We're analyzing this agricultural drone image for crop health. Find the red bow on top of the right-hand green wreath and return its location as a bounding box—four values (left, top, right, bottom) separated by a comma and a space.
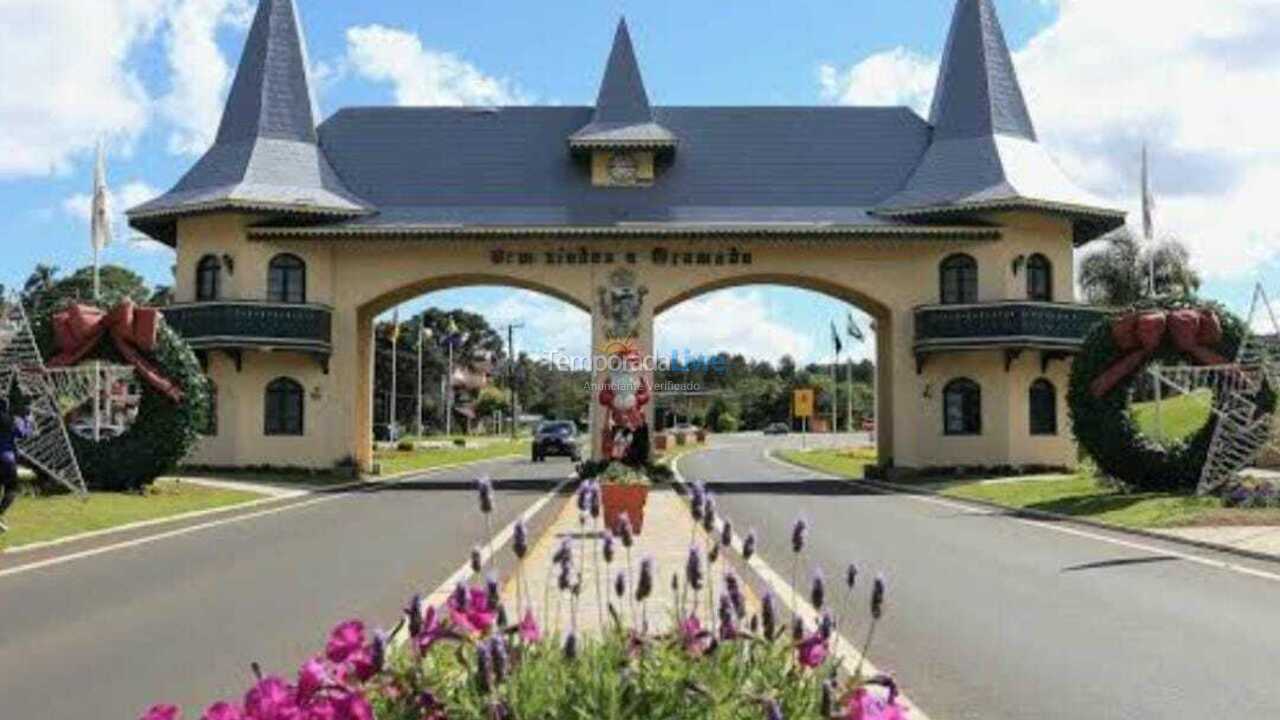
1089, 310, 1228, 397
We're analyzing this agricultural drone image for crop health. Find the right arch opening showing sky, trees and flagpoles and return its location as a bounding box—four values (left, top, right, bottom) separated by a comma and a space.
654, 274, 892, 461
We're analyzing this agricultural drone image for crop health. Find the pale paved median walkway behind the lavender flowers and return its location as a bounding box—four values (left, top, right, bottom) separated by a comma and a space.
503, 487, 759, 634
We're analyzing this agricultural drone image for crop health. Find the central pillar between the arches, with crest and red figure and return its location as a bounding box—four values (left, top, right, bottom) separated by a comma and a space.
590, 268, 657, 464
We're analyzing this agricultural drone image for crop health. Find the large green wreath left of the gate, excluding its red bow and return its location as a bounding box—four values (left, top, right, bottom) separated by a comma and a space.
32, 299, 211, 492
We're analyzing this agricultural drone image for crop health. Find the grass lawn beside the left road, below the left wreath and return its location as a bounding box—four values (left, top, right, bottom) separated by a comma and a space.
0, 480, 262, 547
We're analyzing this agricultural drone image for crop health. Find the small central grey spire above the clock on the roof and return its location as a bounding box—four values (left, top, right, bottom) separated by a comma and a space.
570, 18, 676, 147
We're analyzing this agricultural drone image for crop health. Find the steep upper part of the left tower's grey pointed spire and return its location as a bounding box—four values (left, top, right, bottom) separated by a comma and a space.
218, 0, 316, 142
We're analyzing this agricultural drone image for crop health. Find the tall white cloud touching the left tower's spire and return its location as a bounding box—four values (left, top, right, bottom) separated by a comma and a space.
160, 0, 253, 156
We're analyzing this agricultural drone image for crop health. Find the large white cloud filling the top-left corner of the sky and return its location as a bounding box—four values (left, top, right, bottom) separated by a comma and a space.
0, 0, 165, 178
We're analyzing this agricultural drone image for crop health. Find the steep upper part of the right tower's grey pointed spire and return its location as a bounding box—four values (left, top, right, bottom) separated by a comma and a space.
929, 0, 1036, 141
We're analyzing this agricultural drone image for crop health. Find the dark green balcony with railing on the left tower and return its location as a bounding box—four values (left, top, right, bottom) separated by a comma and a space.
163, 300, 333, 357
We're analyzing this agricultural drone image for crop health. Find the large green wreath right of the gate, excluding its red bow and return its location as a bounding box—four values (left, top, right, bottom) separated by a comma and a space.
1068, 299, 1276, 492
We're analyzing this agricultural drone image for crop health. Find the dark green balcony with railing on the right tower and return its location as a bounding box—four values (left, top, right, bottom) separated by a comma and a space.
915, 301, 1107, 366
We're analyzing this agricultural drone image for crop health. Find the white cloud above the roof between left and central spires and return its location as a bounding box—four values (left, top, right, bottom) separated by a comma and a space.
346, 24, 526, 105
